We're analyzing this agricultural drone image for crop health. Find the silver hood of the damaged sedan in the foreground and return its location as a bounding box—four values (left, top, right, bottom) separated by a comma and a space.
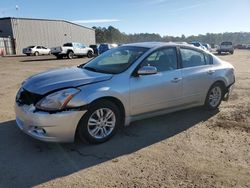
23, 67, 112, 95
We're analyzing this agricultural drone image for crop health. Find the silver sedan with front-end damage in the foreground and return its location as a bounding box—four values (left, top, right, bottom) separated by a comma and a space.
15, 42, 235, 143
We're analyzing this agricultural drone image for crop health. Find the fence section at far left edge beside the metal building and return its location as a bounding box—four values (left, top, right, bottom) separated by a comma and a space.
0, 38, 15, 56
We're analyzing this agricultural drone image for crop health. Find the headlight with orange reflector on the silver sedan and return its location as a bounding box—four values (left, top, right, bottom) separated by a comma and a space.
36, 88, 80, 111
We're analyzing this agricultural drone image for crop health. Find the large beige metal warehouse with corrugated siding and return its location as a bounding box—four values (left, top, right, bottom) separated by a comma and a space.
0, 17, 95, 54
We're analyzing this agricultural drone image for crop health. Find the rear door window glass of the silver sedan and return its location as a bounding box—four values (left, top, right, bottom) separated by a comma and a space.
180, 48, 206, 68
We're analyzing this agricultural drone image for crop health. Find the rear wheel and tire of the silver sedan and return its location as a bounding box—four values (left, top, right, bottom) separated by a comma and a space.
204, 82, 225, 110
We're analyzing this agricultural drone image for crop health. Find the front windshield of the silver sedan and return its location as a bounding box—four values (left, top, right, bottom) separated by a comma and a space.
82, 46, 148, 74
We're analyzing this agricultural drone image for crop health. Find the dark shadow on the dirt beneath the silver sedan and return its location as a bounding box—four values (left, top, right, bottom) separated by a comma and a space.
0, 108, 218, 187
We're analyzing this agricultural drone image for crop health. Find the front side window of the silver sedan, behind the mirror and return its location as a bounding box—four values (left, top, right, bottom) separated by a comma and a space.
141, 48, 177, 72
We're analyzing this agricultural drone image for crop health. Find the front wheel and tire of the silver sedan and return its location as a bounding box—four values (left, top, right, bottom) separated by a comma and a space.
77, 100, 122, 144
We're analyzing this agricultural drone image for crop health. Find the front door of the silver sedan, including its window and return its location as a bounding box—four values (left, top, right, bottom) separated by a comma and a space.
130, 47, 182, 115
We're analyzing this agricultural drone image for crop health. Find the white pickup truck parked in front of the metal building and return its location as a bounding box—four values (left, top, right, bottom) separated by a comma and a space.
51, 42, 94, 59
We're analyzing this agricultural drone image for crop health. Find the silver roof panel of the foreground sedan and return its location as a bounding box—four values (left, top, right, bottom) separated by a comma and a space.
122, 42, 193, 48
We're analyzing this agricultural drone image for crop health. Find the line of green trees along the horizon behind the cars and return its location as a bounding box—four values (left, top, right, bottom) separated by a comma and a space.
93, 26, 250, 45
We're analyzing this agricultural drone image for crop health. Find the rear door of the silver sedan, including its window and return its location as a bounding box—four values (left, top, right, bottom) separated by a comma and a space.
180, 47, 215, 104
